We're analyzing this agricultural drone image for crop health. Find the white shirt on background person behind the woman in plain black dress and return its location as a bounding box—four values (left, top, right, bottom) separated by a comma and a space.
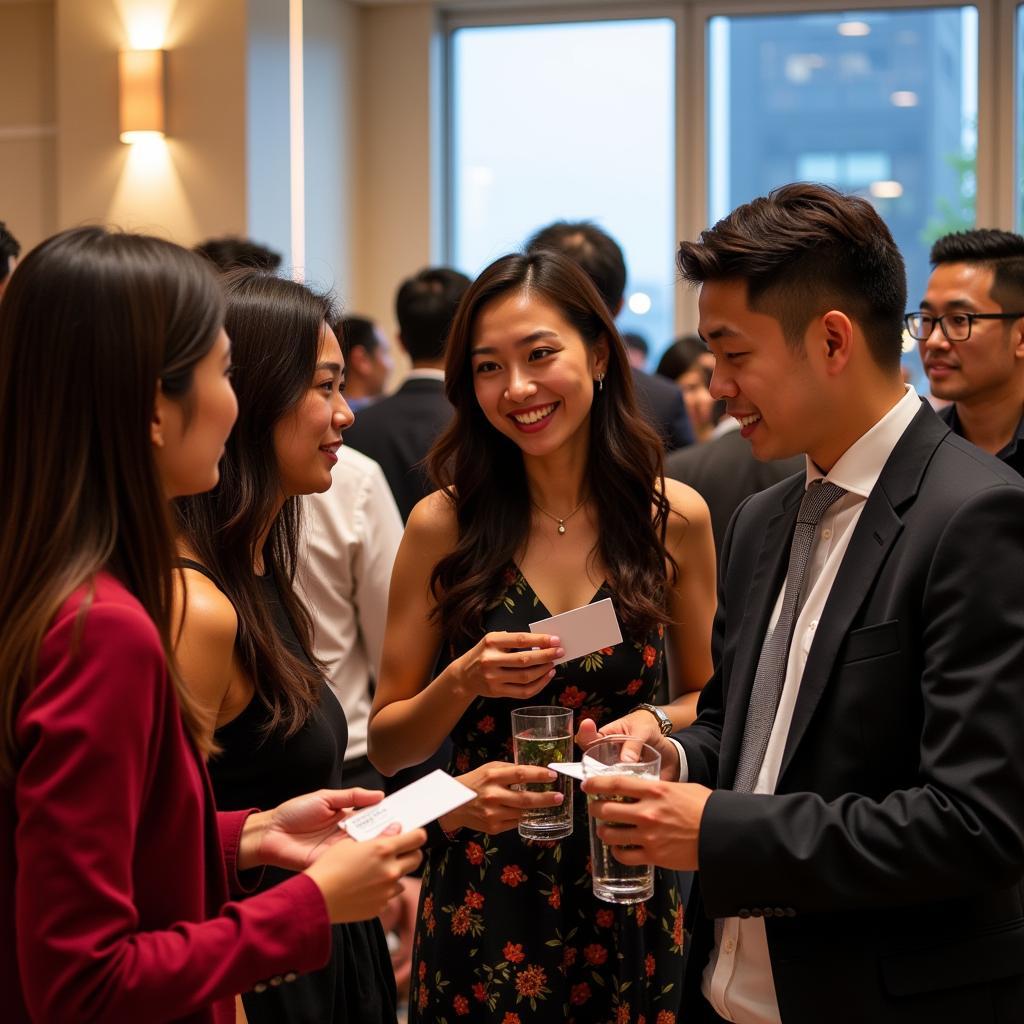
296, 445, 402, 761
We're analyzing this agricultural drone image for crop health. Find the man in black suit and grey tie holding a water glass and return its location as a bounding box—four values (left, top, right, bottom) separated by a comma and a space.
580, 184, 1024, 1024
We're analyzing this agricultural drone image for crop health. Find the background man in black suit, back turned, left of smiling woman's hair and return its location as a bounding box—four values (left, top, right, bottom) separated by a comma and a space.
345, 267, 469, 522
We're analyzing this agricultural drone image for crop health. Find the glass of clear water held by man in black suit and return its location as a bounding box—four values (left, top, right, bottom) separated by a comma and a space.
583, 736, 662, 903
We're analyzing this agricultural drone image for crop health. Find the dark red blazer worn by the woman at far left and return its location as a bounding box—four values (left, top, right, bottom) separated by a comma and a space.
13, 604, 330, 1024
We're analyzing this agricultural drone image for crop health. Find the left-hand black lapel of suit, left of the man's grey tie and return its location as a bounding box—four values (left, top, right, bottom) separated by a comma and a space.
719, 478, 804, 786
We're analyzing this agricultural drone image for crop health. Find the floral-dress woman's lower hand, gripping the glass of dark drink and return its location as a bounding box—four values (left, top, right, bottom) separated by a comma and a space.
438, 761, 563, 836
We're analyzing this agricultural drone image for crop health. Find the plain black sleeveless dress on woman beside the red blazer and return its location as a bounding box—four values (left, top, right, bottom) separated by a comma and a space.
182, 560, 396, 1024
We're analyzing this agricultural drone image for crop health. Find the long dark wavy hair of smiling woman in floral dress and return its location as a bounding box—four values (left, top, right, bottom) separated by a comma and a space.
428, 251, 676, 644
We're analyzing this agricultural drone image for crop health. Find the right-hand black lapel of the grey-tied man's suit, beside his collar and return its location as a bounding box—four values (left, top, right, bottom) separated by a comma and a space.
778, 402, 949, 781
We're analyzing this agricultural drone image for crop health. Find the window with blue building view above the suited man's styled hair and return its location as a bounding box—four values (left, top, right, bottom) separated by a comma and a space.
708, 7, 978, 380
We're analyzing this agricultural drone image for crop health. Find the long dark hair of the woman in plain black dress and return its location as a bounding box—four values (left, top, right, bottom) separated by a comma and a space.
174, 269, 333, 735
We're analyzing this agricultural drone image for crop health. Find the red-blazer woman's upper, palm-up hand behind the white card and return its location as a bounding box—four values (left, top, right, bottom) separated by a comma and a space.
239, 788, 384, 871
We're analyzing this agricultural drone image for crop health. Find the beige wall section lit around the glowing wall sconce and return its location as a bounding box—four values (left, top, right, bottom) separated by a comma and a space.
56, 0, 246, 245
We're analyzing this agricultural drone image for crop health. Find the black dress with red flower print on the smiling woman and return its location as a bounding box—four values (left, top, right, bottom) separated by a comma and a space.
409, 567, 683, 1024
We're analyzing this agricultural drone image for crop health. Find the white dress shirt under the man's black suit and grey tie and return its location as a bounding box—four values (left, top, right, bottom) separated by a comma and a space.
680, 386, 921, 1024
